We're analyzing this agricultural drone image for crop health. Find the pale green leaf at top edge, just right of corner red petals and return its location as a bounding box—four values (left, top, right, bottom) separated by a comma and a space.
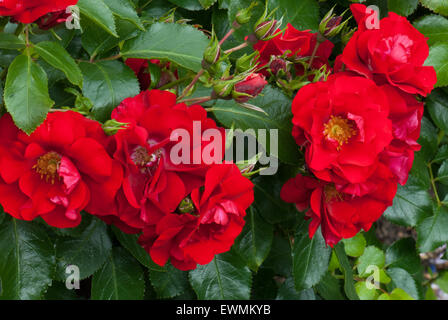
77, 0, 118, 38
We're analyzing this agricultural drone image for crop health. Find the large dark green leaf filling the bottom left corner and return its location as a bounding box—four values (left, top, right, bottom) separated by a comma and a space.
0, 218, 55, 300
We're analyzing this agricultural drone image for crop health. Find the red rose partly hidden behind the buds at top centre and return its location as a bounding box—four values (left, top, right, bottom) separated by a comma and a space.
254, 24, 334, 76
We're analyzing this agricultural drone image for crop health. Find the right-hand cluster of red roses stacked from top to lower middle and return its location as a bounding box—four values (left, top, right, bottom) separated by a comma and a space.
281, 4, 436, 246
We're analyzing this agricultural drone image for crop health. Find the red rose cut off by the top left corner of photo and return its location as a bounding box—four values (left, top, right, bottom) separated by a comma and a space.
0, 0, 78, 23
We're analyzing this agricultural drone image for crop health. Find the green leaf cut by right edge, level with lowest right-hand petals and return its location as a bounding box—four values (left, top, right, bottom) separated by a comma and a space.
417, 207, 448, 252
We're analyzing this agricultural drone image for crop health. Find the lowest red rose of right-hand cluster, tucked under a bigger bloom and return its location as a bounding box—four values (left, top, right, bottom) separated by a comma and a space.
280, 165, 397, 247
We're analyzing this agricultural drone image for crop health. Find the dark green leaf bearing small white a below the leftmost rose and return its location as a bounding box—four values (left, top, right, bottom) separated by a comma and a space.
56, 218, 112, 280
